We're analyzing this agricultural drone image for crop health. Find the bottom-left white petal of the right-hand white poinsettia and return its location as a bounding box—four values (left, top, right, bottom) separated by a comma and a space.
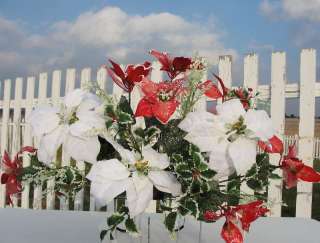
209, 139, 235, 179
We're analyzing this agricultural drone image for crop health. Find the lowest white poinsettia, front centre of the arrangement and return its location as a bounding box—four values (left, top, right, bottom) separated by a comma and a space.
87, 137, 181, 217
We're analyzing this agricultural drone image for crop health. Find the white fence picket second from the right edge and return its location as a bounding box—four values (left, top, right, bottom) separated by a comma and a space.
268, 52, 286, 217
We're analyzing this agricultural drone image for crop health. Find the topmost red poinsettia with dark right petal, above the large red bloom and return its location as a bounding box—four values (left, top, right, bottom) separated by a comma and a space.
150, 50, 192, 79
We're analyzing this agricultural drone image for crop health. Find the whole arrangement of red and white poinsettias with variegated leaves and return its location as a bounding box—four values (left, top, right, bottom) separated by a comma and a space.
1, 50, 320, 243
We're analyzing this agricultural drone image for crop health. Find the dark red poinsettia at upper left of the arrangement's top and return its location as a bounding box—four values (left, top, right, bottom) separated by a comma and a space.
106, 60, 151, 93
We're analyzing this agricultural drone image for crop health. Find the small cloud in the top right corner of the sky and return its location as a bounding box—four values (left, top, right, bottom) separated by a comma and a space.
260, 0, 320, 21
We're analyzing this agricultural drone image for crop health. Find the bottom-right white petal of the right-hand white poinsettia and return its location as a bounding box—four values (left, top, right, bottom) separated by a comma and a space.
228, 137, 257, 175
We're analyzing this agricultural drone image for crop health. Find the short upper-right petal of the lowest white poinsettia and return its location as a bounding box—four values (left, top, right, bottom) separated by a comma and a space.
142, 147, 169, 170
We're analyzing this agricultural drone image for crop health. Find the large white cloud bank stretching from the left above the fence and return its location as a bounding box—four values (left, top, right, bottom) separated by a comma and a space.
0, 7, 237, 77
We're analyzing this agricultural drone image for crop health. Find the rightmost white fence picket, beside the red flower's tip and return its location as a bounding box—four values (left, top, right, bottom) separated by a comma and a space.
296, 49, 316, 218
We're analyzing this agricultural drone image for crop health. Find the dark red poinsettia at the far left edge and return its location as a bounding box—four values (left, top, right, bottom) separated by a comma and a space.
1, 146, 36, 204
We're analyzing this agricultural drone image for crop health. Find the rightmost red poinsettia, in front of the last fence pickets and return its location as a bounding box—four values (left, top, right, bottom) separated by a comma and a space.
281, 145, 320, 189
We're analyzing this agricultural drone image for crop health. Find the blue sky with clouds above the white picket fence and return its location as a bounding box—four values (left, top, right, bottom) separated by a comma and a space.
0, 0, 320, 113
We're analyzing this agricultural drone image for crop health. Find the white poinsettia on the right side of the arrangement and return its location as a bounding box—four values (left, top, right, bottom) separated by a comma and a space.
179, 99, 275, 178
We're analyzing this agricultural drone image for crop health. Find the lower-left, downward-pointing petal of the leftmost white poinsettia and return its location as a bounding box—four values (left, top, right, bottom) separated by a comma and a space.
37, 126, 67, 164
